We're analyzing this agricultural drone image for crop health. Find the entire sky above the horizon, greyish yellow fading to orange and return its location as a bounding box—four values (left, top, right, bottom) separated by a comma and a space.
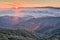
0, 0, 60, 8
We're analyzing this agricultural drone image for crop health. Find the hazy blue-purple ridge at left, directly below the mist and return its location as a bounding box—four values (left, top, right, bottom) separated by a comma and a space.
0, 16, 34, 27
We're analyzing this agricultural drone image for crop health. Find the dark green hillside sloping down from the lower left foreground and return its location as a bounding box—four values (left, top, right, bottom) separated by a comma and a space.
0, 28, 40, 40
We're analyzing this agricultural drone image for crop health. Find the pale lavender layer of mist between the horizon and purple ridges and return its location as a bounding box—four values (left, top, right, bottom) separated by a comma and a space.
0, 8, 60, 17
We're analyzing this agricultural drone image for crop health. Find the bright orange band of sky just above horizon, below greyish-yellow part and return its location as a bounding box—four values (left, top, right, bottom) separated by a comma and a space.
0, 3, 60, 8
